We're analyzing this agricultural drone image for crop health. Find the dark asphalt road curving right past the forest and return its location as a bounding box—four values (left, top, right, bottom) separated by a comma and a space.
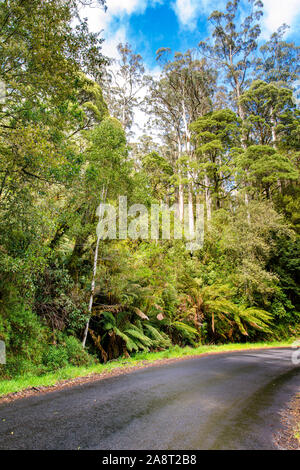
0, 349, 300, 450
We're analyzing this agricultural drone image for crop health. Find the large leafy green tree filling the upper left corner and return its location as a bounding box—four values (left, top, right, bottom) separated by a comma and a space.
0, 0, 105, 209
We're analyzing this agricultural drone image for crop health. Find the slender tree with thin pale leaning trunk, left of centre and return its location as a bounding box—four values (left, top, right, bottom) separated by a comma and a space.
67, 117, 132, 346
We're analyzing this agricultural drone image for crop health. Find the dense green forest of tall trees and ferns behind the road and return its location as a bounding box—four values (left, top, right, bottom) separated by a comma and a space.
0, 0, 300, 378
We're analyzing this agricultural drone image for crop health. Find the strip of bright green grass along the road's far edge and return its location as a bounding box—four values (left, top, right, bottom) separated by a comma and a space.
0, 339, 294, 397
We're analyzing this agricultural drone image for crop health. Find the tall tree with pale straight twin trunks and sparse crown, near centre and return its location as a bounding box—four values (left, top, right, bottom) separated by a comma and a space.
150, 48, 216, 232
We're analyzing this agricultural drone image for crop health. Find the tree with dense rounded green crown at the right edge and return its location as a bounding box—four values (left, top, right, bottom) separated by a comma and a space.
238, 80, 299, 199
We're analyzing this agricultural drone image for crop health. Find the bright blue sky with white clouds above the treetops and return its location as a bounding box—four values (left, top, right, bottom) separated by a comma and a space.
82, 0, 300, 71
